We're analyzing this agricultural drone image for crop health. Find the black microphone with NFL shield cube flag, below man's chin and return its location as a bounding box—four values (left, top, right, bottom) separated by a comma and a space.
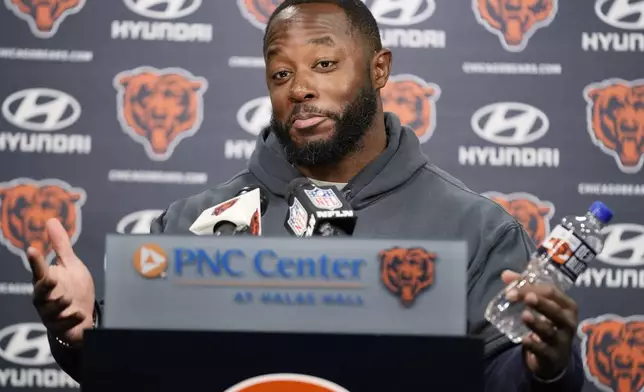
284, 177, 358, 237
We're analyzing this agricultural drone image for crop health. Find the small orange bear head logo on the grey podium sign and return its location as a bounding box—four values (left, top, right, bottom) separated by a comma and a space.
378, 247, 437, 307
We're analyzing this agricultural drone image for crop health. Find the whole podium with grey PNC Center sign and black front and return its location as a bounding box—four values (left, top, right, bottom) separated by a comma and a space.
82, 235, 484, 392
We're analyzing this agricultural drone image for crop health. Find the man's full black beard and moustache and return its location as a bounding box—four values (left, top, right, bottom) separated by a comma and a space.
270, 84, 378, 167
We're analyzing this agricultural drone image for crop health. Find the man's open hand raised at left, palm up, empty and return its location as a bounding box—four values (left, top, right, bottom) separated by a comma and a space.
27, 219, 95, 345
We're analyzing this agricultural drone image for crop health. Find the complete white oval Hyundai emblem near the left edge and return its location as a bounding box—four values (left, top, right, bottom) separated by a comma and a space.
1, 88, 81, 132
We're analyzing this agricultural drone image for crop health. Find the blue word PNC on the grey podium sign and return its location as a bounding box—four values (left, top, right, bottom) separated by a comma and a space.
174, 248, 245, 277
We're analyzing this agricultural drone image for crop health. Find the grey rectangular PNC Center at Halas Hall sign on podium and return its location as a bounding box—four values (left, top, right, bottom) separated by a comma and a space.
103, 235, 467, 336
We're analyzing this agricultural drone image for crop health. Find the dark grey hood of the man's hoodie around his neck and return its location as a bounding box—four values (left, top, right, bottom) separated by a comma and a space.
248, 113, 428, 208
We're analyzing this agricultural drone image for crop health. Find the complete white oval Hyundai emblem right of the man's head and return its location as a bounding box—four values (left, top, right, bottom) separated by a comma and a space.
471, 102, 550, 146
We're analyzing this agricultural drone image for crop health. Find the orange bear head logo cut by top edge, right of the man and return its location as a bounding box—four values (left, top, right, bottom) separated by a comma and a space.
472, 0, 558, 52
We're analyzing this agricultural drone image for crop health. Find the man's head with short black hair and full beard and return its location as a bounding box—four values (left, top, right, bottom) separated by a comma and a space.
264, 0, 391, 166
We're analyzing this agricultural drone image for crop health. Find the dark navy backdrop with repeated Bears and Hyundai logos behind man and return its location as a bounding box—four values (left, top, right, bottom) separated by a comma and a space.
0, 0, 644, 392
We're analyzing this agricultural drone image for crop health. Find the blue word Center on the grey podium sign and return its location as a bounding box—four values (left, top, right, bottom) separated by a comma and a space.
253, 249, 367, 280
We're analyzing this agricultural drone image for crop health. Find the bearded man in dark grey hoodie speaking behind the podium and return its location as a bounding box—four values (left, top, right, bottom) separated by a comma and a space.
28, 0, 583, 392
